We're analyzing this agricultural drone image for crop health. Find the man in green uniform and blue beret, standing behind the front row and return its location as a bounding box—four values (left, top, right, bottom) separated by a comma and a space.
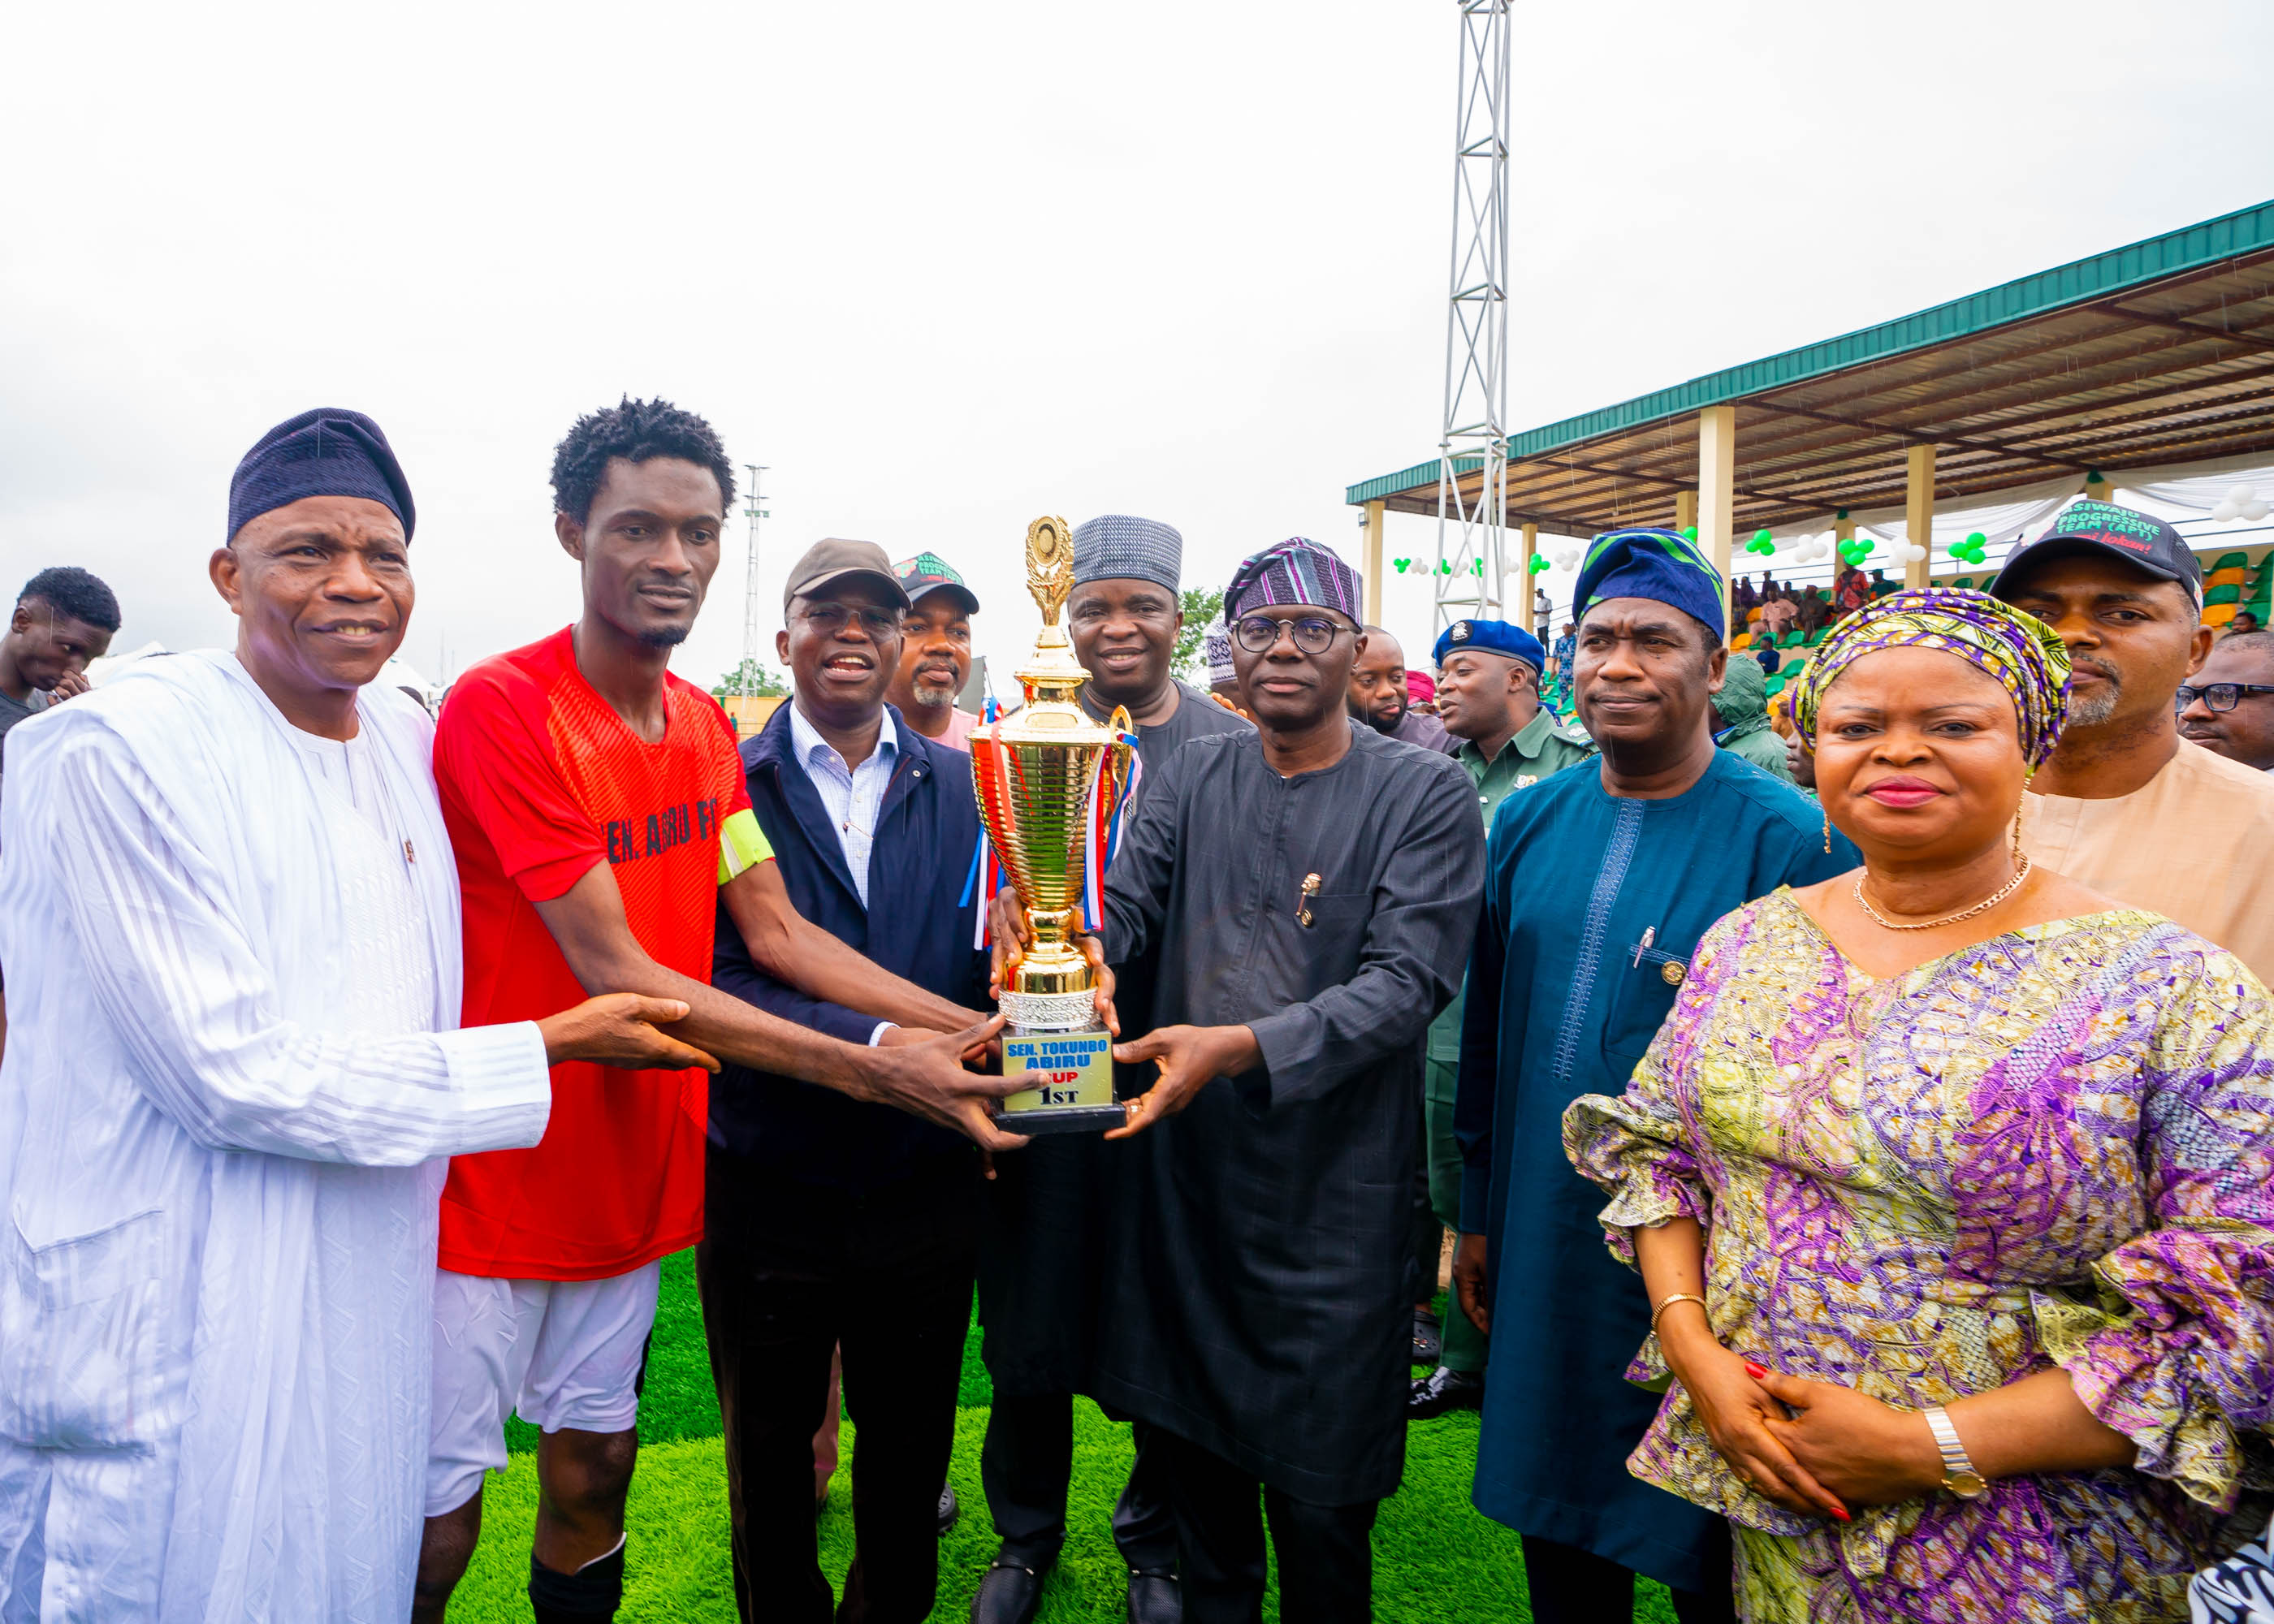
1405, 621, 1594, 1422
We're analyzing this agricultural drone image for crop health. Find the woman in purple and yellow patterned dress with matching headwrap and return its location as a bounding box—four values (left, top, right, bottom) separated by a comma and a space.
1564, 591, 2274, 1624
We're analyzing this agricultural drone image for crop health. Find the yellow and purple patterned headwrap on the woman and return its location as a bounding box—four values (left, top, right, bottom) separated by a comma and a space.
1792, 587, 2069, 771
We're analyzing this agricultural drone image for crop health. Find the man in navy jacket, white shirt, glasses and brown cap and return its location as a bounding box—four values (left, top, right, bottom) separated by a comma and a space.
698, 542, 987, 1624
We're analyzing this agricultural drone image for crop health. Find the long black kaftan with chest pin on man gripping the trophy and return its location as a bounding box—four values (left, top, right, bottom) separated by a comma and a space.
1092, 726, 1485, 1505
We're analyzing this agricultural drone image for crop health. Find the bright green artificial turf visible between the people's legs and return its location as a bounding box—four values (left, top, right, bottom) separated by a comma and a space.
450, 1253, 1674, 1624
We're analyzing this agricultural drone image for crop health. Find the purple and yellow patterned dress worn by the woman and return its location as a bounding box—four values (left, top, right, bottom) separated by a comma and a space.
1564, 889, 2274, 1624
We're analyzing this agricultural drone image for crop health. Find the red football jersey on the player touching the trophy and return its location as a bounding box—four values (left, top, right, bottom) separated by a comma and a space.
434, 630, 771, 1281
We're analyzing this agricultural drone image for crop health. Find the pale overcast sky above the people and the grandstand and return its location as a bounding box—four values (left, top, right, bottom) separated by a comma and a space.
0, 0, 2274, 685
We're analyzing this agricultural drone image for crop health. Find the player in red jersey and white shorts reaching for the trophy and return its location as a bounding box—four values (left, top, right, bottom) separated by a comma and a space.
421, 412, 1023, 1624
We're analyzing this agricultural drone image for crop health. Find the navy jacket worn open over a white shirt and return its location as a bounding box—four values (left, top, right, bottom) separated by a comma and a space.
710, 703, 989, 1196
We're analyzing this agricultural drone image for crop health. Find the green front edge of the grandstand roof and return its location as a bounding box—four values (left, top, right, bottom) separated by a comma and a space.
1342, 200, 2274, 508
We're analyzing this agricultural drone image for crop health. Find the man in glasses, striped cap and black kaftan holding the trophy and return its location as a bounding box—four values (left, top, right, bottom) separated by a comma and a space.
1023, 539, 1485, 1624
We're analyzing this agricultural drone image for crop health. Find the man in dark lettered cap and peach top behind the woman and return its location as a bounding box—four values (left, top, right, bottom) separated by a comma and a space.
1990, 500, 2274, 980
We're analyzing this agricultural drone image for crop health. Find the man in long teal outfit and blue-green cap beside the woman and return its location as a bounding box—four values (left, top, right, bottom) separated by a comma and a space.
1453, 530, 1858, 1624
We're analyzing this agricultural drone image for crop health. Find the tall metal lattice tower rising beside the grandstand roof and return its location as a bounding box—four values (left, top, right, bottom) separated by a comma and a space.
1433, 0, 1530, 630
